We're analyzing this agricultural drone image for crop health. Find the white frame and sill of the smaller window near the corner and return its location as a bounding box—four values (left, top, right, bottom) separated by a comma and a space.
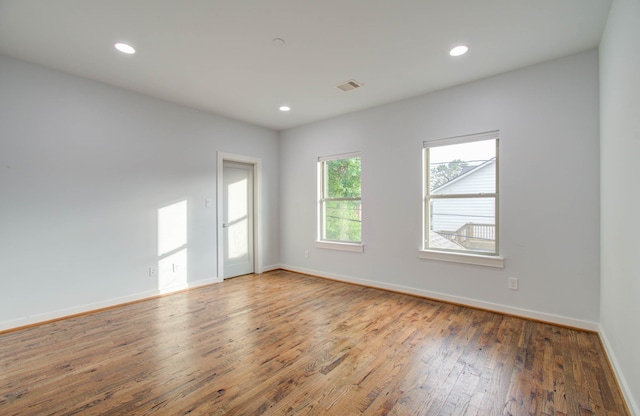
315, 152, 364, 252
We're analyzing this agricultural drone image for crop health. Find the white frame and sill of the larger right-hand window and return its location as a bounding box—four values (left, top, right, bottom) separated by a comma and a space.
419, 130, 504, 267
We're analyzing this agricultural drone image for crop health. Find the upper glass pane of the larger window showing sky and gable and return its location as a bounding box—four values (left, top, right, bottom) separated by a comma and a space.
428, 139, 496, 195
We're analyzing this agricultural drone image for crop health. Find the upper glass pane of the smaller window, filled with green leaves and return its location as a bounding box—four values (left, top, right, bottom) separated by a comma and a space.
325, 157, 360, 198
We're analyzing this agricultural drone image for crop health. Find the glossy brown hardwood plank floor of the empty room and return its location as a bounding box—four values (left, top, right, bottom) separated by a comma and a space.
0, 271, 628, 416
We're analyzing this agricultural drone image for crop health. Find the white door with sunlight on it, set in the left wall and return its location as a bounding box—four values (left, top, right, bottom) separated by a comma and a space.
222, 161, 254, 279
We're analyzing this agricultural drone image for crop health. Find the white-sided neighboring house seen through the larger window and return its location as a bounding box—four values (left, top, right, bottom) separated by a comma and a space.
431, 158, 496, 249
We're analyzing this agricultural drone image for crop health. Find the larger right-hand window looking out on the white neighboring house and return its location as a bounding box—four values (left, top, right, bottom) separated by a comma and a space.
423, 131, 502, 267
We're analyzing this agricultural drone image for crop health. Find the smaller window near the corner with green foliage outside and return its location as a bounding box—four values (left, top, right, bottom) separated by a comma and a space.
318, 153, 362, 251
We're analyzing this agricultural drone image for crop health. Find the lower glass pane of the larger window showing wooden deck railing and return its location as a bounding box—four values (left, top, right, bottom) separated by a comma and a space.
428, 198, 496, 253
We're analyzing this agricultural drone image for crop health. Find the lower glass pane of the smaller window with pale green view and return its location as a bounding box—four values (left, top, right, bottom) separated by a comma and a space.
324, 201, 362, 242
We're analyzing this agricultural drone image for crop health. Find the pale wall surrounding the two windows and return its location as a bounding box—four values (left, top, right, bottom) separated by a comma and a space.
280, 50, 600, 328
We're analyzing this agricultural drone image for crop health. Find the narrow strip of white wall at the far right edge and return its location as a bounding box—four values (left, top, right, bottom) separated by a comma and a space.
600, 0, 640, 415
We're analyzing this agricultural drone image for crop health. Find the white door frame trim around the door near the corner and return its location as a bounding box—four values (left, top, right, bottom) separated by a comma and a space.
216, 152, 262, 280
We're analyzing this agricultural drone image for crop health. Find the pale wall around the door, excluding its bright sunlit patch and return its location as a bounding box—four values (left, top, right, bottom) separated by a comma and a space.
0, 57, 279, 329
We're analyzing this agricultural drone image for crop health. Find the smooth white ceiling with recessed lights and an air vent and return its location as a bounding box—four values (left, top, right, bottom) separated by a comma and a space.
0, 0, 611, 130
